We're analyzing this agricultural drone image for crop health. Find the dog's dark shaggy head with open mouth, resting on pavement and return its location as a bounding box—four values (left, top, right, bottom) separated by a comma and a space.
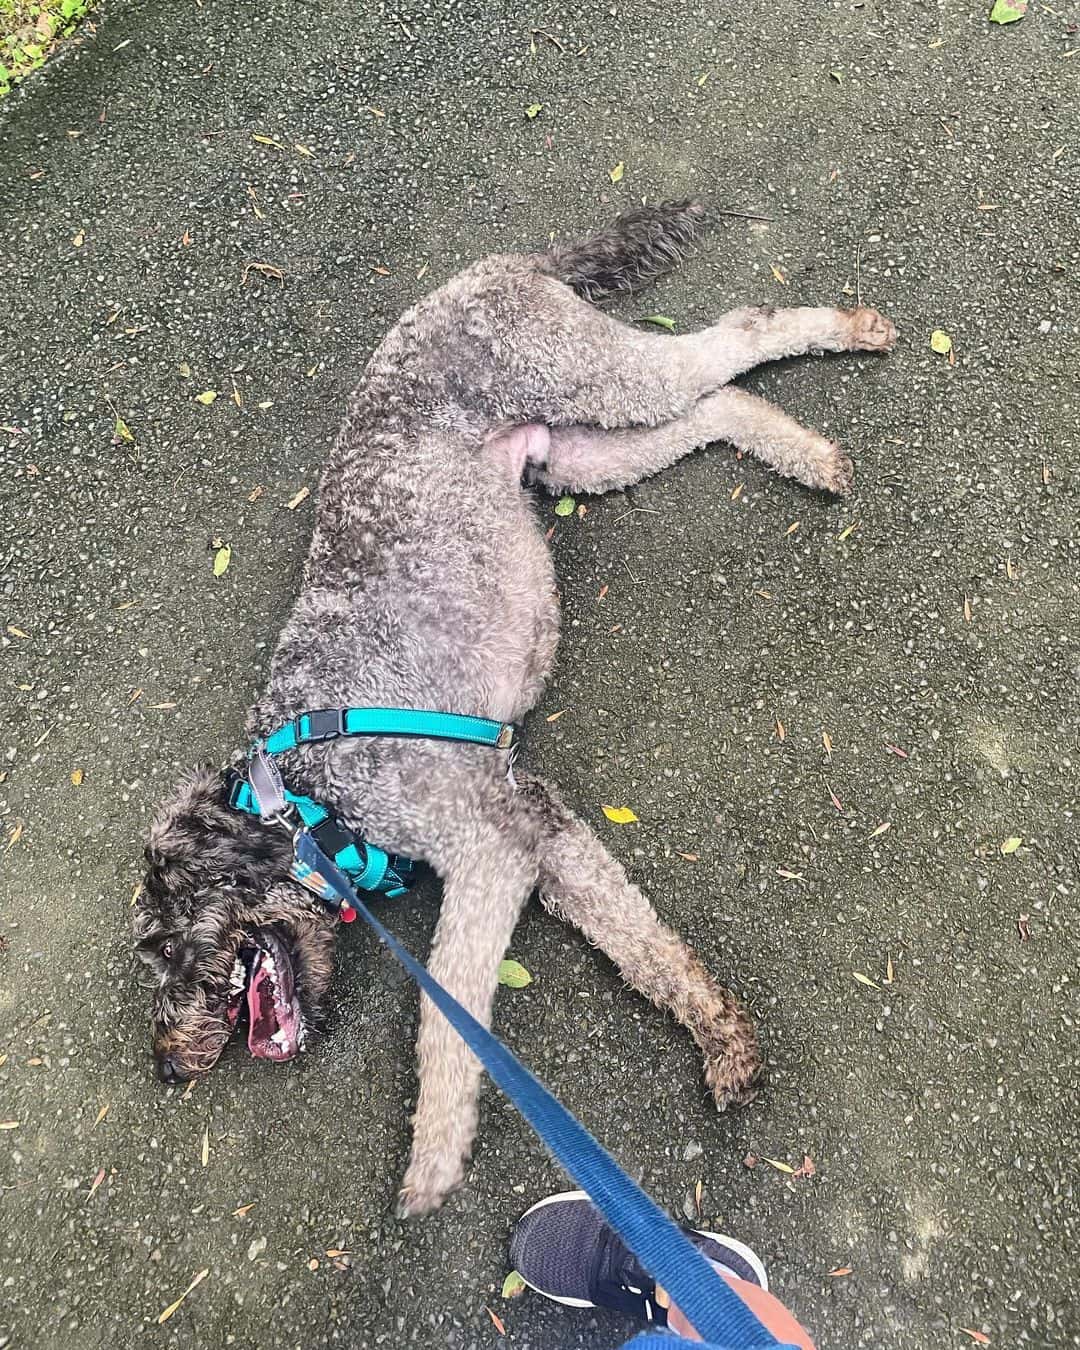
135, 768, 336, 1083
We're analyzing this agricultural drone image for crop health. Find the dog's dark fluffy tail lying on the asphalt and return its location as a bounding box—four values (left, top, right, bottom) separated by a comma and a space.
541, 198, 706, 300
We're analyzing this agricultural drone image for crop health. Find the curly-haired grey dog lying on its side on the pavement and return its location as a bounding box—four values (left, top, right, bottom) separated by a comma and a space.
135, 203, 895, 1214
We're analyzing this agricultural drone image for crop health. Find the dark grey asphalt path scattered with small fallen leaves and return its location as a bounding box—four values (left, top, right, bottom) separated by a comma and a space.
0, 0, 1080, 1350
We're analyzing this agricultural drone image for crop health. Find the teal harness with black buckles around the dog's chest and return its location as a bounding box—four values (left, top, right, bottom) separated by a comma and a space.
227, 707, 514, 923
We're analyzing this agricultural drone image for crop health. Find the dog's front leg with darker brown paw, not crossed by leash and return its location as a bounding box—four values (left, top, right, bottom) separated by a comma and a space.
520, 775, 760, 1110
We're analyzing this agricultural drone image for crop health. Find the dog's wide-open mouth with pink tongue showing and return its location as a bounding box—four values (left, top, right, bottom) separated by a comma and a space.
227, 927, 304, 1060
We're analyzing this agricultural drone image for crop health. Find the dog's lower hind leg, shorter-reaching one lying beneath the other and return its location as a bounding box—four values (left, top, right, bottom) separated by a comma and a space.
536, 387, 852, 493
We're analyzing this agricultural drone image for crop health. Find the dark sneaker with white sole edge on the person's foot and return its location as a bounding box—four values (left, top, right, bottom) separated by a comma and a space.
510, 1191, 768, 1326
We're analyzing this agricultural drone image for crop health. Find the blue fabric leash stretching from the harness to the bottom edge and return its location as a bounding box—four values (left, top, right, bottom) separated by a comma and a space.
296, 830, 779, 1350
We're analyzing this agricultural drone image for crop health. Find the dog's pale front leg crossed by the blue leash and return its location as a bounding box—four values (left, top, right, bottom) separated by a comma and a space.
398, 826, 536, 1218
